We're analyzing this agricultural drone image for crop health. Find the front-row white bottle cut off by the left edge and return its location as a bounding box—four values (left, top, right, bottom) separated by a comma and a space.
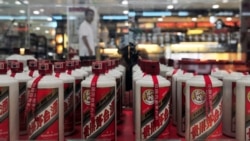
0, 61, 19, 141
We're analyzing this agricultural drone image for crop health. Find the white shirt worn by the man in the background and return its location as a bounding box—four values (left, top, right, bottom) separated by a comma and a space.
79, 21, 95, 56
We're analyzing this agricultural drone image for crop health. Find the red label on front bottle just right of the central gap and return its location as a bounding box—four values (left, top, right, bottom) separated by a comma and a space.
140, 87, 171, 140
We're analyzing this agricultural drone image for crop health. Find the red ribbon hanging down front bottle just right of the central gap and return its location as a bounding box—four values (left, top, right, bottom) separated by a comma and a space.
152, 75, 159, 125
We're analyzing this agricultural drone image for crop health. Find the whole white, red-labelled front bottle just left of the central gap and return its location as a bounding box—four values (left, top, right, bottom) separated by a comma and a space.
81, 61, 117, 141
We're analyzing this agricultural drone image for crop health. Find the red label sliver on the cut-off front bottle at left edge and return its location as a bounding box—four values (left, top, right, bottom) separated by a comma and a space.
0, 87, 10, 140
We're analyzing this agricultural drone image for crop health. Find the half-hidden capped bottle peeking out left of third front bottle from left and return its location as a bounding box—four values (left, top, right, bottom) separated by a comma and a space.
65, 60, 87, 124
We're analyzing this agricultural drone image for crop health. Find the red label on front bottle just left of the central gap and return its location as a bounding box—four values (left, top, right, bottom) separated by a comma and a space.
82, 87, 116, 141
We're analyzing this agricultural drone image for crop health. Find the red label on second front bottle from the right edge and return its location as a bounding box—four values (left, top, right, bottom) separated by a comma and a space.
189, 87, 222, 140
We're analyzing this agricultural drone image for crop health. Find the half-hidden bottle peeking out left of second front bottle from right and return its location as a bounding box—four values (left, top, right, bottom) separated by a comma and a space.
176, 75, 193, 137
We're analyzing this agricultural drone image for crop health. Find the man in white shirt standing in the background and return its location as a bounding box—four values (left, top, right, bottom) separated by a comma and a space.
79, 8, 95, 60
